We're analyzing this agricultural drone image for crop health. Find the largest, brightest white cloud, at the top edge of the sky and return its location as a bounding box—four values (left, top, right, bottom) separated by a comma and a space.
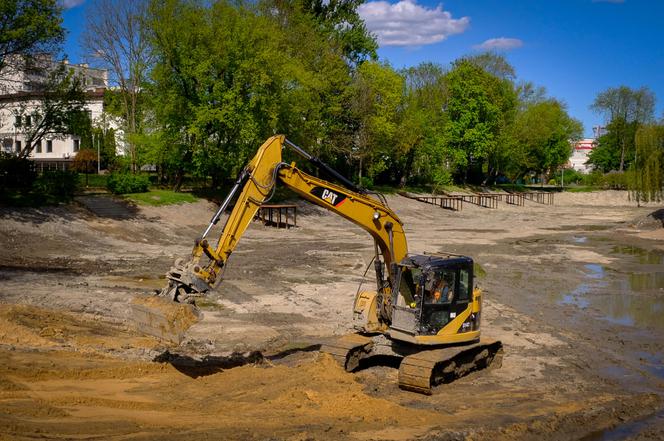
357, 0, 470, 46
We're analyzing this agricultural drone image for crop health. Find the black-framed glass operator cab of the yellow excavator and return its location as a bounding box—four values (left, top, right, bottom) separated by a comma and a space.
390, 254, 480, 345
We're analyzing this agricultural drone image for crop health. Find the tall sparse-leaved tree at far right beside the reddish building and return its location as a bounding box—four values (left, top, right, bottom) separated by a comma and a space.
589, 86, 655, 171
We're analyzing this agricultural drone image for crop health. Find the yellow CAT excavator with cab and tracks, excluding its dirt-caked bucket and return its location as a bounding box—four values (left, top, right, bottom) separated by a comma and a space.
143, 136, 502, 394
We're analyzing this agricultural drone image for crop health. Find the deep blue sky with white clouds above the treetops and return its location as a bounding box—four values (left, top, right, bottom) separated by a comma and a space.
64, 0, 664, 136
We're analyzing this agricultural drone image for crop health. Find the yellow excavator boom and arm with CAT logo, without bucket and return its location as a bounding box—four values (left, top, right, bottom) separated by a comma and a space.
165, 135, 408, 300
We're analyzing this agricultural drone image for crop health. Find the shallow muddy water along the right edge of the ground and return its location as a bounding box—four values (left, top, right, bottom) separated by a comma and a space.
557, 236, 664, 434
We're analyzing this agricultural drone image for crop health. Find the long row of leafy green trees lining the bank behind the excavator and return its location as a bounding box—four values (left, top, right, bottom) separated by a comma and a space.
118, 0, 592, 188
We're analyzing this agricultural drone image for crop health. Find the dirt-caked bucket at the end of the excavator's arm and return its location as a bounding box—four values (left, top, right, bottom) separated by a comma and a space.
130, 295, 200, 344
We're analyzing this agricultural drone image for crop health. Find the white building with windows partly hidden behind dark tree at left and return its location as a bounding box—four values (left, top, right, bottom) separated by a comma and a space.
0, 58, 115, 168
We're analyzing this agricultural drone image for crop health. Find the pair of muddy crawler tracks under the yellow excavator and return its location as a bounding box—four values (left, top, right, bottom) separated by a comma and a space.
321, 334, 503, 395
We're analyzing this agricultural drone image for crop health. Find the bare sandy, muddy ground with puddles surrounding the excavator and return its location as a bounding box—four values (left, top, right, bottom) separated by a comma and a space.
0, 192, 664, 441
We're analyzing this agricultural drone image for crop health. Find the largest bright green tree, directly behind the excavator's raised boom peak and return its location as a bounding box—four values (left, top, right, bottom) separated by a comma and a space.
146, 0, 364, 185
